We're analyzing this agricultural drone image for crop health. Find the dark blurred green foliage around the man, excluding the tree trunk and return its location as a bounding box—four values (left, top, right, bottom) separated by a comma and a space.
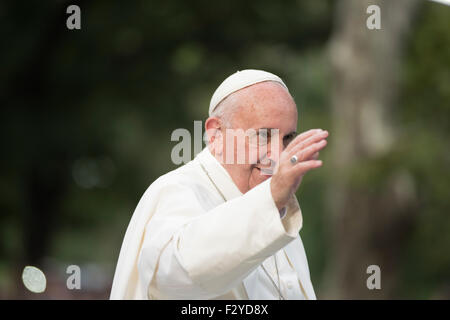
0, 1, 450, 298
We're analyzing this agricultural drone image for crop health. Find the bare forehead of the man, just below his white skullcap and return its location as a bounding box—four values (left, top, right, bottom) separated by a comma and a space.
234, 82, 298, 133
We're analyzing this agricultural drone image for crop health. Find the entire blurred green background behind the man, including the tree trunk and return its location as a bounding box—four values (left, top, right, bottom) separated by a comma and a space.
0, 0, 450, 299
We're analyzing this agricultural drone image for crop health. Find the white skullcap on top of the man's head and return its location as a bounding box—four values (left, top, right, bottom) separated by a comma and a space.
209, 69, 287, 116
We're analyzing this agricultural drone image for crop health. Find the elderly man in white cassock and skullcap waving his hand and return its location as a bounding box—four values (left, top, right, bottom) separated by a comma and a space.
111, 70, 328, 299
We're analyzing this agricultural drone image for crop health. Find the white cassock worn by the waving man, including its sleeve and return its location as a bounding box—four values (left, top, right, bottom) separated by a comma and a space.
111, 148, 316, 299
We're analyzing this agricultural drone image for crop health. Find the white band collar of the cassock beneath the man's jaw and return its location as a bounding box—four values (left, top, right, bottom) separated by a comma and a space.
195, 146, 242, 201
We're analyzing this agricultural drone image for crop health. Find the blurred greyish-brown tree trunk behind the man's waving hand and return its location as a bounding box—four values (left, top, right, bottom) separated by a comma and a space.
326, 0, 417, 299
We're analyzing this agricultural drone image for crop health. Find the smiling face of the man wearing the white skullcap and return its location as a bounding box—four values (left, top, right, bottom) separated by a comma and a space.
221, 82, 298, 193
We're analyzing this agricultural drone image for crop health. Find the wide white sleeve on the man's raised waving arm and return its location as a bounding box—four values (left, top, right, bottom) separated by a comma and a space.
138, 179, 302, 299
